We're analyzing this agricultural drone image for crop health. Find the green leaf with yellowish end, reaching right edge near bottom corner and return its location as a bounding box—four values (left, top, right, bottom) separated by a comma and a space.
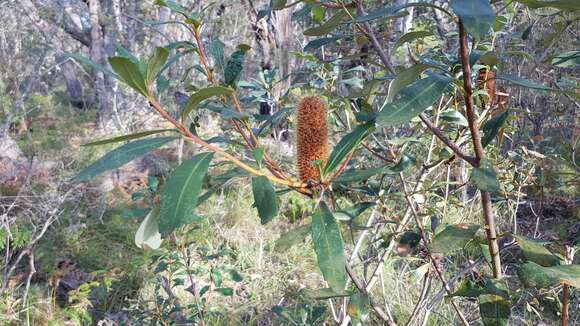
518, 262, 580, 288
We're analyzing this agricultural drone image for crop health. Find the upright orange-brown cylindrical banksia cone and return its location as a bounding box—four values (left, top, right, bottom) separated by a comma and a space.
297, 96, 328, 182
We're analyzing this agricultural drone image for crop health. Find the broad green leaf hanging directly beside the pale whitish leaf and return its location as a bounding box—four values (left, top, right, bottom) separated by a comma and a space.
159, 153, 213, 236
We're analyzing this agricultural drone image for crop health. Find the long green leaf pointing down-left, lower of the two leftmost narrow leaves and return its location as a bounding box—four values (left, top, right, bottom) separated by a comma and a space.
72, 137, 176, 183
